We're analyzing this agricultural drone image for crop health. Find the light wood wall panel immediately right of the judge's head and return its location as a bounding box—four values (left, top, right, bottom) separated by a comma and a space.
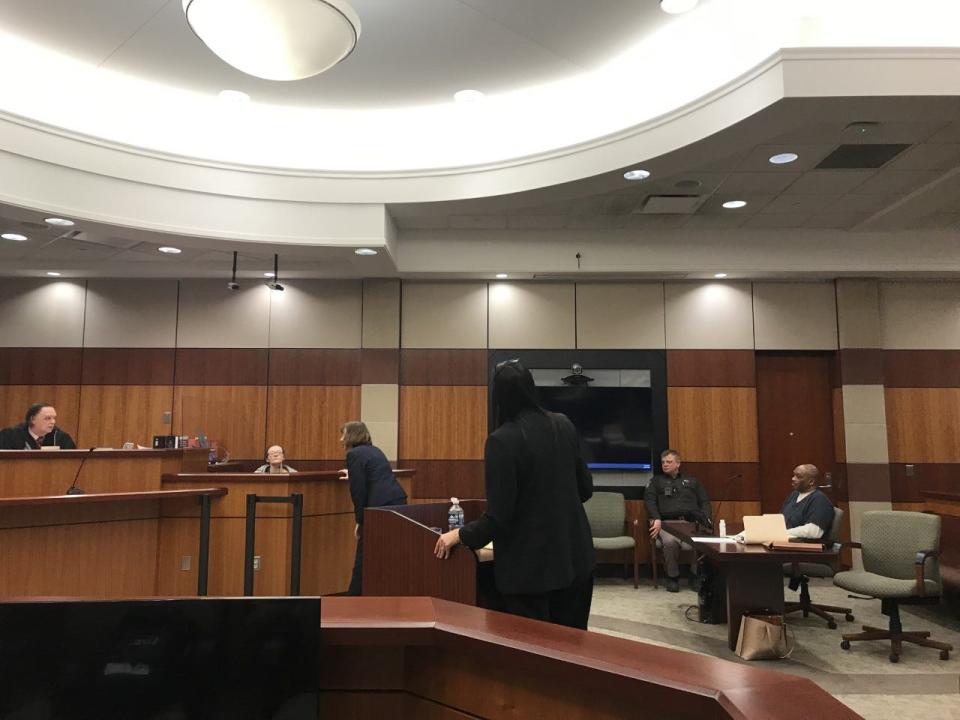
77, 385, 174, 448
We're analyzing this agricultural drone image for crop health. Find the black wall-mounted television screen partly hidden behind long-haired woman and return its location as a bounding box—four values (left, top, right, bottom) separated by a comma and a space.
537, 385, 653, 470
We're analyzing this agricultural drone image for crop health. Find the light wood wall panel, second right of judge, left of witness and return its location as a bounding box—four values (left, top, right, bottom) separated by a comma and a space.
173, 386, 267, 458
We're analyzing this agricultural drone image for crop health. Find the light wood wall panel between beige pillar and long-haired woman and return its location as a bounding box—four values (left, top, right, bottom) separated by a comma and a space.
400, 385, 487, 460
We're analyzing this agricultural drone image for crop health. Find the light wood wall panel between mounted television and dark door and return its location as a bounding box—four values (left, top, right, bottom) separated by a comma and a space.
667, 387, 758, 462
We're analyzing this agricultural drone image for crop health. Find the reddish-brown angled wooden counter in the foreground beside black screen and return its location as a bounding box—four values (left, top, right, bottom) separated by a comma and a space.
320, 597, 860, 720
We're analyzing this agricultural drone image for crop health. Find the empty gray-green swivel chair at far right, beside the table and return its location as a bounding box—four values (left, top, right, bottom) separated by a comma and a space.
833, 510, 953, 662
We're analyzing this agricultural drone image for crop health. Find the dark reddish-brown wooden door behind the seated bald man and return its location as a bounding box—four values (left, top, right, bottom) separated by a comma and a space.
757, 353, 838, 513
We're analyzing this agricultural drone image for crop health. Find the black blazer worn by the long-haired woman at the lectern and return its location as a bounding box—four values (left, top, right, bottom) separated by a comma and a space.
460, 412, 594, 594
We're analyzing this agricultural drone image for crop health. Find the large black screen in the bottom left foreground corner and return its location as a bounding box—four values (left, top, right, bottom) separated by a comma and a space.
0, 598, 320, 720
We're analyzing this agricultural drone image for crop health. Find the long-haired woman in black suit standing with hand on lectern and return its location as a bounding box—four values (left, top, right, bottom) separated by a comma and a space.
434, 360, 593, 630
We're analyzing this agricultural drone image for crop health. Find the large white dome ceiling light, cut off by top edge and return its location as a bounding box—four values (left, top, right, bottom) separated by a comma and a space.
181, 0, 360, 80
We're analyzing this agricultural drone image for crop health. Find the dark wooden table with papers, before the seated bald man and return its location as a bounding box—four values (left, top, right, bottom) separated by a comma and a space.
670, 528, 839, 650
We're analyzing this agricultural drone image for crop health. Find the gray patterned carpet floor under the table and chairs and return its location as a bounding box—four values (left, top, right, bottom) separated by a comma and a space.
590, 578, 960, 720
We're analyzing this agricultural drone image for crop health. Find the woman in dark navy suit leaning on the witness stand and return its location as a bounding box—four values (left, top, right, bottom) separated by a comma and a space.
340, 420, 407, 595
